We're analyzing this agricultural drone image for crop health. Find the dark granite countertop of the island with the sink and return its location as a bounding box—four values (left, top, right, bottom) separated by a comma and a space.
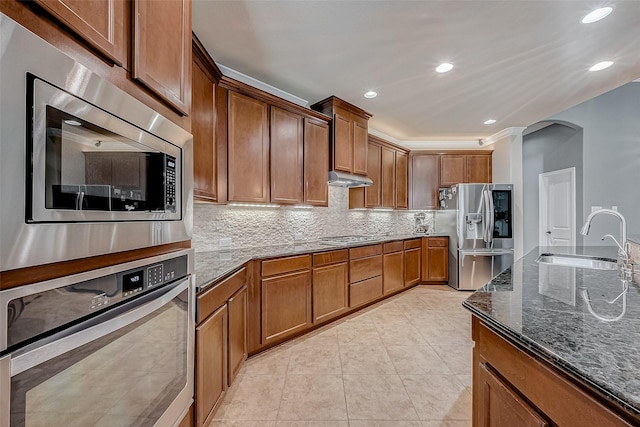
463, 246, 640, 417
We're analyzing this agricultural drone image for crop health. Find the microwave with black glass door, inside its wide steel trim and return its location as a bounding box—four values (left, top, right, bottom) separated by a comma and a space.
27, 76, 180, 222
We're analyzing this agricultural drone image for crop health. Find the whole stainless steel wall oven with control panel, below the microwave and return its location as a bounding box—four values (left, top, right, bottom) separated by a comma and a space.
0, 250, 195, 427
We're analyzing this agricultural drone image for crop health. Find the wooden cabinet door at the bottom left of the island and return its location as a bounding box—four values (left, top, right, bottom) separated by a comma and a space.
474, 363, 549, 427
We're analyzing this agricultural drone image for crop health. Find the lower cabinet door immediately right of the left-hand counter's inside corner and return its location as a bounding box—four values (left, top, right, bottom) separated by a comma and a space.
261, 271, 311, 345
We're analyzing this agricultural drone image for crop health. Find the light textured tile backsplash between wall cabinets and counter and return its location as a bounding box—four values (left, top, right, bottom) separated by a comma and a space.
192, 187, 435, 251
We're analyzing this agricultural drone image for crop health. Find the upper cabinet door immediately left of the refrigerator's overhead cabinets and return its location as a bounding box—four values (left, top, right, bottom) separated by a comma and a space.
409, 154, 440, 209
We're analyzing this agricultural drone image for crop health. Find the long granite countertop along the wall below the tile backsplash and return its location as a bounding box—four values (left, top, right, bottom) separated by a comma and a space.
195, 233, 446, 292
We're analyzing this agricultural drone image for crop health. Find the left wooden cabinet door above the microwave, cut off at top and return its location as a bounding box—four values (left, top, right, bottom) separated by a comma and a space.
35, 0, 127, 68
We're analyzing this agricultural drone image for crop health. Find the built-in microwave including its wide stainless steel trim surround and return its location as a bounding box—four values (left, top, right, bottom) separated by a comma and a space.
0, 14, 193, 271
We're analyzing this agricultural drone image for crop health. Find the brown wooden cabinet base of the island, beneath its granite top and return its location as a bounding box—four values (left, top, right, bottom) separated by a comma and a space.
472, 316, 640, 427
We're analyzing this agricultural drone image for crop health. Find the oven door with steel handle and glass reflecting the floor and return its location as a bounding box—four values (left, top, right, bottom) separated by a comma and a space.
6, 279, 193, 427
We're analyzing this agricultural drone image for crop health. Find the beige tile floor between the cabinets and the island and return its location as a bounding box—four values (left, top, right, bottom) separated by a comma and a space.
212, 286, 473, 427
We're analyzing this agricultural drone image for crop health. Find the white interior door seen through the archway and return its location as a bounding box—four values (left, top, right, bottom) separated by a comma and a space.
538, 168, 576, 247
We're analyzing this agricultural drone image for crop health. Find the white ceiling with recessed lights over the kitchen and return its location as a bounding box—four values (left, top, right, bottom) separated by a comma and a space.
193, 0, 640, 145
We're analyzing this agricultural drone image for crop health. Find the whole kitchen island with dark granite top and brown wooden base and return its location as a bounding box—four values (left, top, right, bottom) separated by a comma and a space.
463, 247, 640, 426
